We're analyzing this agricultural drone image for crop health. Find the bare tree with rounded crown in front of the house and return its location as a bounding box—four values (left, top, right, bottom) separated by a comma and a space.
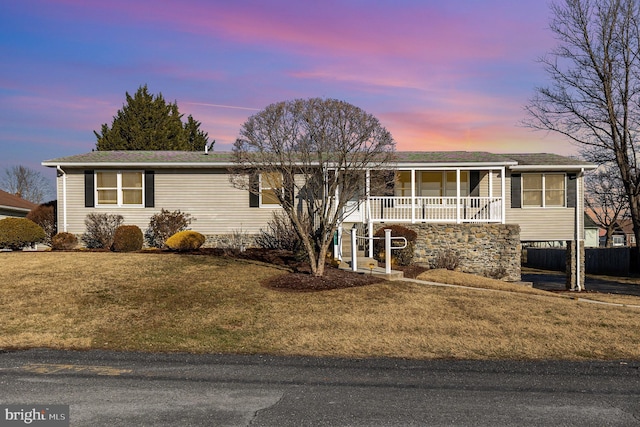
232, 98, 395, 276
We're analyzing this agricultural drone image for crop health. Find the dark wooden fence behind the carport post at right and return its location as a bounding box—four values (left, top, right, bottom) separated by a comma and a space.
523, 248, 631, 276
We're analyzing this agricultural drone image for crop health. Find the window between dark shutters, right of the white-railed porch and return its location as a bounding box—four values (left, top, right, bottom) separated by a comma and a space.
522, 173, 565, 207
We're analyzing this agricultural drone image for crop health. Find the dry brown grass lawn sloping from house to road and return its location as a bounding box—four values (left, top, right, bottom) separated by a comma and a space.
0, 252, 640, 359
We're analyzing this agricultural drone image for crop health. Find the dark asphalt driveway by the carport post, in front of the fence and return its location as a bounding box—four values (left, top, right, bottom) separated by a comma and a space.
522, 269, 640, 296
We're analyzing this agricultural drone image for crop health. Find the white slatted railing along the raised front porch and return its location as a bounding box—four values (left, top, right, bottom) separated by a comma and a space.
368, 196, 502, 222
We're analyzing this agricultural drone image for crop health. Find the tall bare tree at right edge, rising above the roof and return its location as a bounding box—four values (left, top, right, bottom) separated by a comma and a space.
525, 0, 640, 264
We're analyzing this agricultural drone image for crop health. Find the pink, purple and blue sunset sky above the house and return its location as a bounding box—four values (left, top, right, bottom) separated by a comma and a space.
0, 0, 575, 190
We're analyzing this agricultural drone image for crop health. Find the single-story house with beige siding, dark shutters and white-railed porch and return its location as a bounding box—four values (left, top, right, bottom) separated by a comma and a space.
42, 151, 595, 284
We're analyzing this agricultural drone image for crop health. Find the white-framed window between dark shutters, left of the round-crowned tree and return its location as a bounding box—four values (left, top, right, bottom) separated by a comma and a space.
95, 171, 144, 206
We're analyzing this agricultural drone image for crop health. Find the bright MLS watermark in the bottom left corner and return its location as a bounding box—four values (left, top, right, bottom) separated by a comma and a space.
0, 405, 69, 427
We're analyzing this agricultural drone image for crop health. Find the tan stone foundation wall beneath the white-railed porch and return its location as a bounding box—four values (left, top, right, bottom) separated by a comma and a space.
381, 224, 522, 282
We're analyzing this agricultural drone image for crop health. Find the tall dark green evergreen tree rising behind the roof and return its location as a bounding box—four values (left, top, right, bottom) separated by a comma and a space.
93, 85, 208, 151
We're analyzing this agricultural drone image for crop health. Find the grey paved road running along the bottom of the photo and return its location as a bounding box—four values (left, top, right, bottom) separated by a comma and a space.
0, 350, 640, 427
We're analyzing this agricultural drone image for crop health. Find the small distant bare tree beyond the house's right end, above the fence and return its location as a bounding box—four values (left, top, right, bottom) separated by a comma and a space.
585, 164, 629, 247
